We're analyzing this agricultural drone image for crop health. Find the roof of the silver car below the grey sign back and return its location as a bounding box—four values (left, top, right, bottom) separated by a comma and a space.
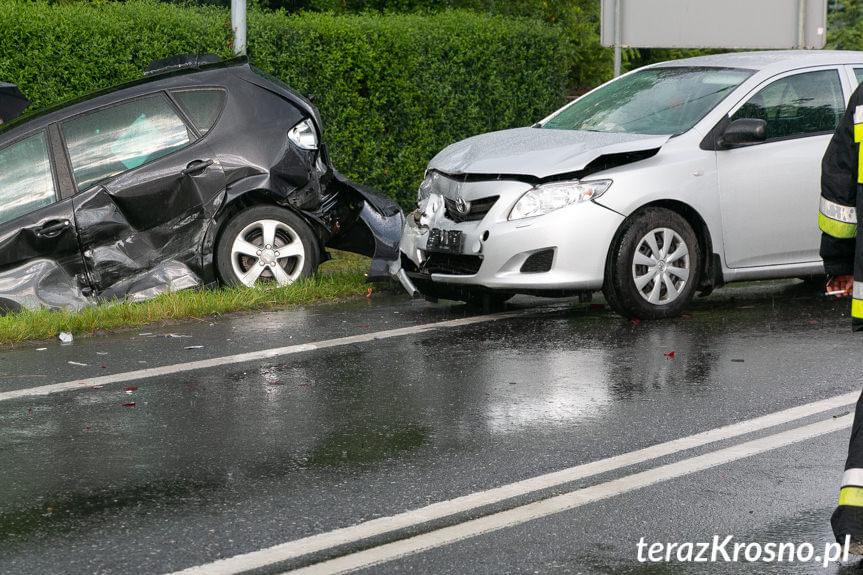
649, 50, 863, 72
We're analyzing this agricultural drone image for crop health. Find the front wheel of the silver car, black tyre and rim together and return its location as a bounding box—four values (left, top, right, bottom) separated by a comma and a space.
602, 208, 701, 319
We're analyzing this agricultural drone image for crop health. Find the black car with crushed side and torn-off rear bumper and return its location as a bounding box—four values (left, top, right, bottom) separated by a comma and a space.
0, 57, 403, 309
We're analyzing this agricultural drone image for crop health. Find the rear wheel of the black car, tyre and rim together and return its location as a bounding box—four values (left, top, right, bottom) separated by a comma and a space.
216, 205, 320, 286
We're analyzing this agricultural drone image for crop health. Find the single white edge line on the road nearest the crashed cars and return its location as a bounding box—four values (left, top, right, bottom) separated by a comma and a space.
0, 310, 537, 401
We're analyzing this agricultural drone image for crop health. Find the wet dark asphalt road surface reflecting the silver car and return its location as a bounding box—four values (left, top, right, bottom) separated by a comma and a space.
0, 282, 863, 574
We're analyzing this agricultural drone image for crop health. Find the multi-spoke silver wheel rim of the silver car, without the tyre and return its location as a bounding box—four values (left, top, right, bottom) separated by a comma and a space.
632, 228, 692, 305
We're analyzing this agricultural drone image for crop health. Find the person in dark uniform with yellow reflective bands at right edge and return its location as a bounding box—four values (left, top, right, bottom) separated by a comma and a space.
818, 81, 863, 555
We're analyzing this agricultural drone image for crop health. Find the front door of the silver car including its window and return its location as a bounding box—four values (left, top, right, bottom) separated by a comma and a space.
717, 68, 845, 268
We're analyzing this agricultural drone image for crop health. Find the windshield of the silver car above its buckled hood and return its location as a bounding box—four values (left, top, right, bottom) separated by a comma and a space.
542, 67, 752, 135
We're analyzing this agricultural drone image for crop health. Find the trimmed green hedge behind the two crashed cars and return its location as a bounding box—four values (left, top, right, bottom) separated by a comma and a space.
5, 0, 575, 206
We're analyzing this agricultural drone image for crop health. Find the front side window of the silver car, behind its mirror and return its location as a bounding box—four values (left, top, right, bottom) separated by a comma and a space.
731, 70, 845, 140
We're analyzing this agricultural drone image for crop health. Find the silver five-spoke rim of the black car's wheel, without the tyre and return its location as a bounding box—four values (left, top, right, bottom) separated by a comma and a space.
231, 220, 306, 287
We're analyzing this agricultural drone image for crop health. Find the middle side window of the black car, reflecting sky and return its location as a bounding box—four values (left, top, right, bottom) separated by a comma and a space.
62, 94, 191, 191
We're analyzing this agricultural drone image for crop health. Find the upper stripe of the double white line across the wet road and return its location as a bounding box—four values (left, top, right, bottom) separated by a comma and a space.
165, 391, 860, 575
